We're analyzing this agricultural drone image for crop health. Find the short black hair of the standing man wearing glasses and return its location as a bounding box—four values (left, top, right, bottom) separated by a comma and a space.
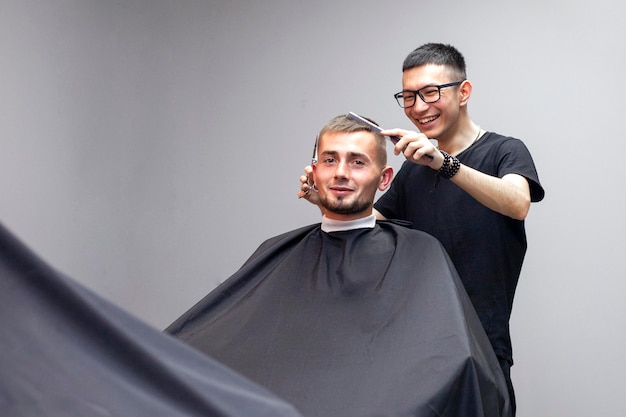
402, 43, 467, 81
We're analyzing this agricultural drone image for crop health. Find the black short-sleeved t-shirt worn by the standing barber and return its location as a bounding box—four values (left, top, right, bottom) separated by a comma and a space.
375, 132, 544, 362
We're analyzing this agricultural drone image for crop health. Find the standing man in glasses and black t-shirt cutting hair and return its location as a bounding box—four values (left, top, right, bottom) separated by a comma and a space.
299, 43, 544, 409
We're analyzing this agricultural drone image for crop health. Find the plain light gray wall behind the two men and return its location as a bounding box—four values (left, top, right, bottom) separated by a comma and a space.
0, 0, 626, 417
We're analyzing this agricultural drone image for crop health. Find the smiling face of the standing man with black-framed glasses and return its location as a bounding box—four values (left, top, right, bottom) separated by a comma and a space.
402, 64, 462, 139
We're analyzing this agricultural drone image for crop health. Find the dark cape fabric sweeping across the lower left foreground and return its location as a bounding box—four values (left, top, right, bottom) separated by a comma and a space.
0, 226, 300, 417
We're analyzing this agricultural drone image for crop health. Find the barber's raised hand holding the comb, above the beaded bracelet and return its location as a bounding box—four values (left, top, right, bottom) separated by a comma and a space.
380, 129, 443, 170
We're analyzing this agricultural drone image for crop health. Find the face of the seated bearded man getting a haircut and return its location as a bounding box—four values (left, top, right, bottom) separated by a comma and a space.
313, 131, 392, 220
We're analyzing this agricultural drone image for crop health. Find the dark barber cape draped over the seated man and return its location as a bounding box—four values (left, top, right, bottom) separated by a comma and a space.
166, 222, 509, 417
